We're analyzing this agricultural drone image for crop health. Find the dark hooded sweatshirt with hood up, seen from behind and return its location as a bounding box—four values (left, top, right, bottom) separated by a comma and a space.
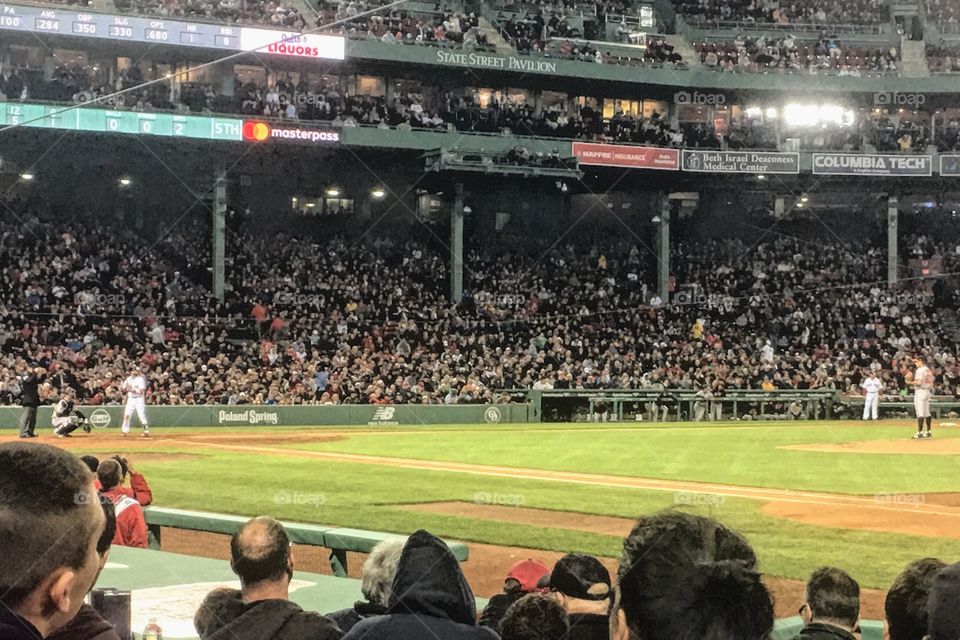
344, 530, 498, 640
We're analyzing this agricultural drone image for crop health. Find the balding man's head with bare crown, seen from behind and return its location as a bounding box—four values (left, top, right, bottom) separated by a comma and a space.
230, 516, 293, 587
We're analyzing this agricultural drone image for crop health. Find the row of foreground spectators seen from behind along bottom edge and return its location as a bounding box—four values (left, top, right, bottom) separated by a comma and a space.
0, 443, 960, 640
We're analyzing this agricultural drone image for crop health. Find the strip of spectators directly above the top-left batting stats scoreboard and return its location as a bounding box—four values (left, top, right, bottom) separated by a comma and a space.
113, 0, 306, 31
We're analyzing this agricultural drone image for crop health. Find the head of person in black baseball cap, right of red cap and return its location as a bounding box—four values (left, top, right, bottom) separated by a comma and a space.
550, 553, 612, 640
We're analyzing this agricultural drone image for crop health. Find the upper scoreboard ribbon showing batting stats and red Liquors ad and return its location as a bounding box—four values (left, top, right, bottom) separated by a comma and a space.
0, 3, 346, 60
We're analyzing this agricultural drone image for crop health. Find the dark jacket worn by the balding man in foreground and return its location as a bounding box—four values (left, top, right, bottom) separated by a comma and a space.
194, 589, 343, 640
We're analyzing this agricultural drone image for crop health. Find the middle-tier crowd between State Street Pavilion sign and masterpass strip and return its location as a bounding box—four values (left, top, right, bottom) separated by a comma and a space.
11, 59, 948, 152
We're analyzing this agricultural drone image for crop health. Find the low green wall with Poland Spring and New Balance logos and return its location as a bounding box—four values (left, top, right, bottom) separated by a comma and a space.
0, 404, 534, 431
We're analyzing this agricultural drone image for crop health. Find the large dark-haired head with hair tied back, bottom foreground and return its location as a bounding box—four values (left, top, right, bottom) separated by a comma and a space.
610, 512, 773, 640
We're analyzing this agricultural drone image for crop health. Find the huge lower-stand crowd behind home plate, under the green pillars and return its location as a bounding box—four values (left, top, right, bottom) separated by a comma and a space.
0, 194, 958, 404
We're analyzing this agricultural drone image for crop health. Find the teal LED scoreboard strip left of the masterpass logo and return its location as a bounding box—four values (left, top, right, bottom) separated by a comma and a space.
0, 102, 243, 141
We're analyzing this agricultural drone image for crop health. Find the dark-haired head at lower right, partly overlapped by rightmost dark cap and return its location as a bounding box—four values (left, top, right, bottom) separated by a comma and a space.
883, 558, 947, 640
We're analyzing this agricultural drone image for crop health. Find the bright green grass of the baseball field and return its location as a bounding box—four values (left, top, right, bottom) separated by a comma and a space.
69, 422, 960, 588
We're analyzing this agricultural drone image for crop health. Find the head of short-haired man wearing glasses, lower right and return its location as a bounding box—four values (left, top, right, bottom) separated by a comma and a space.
794, 567, 860, 640
